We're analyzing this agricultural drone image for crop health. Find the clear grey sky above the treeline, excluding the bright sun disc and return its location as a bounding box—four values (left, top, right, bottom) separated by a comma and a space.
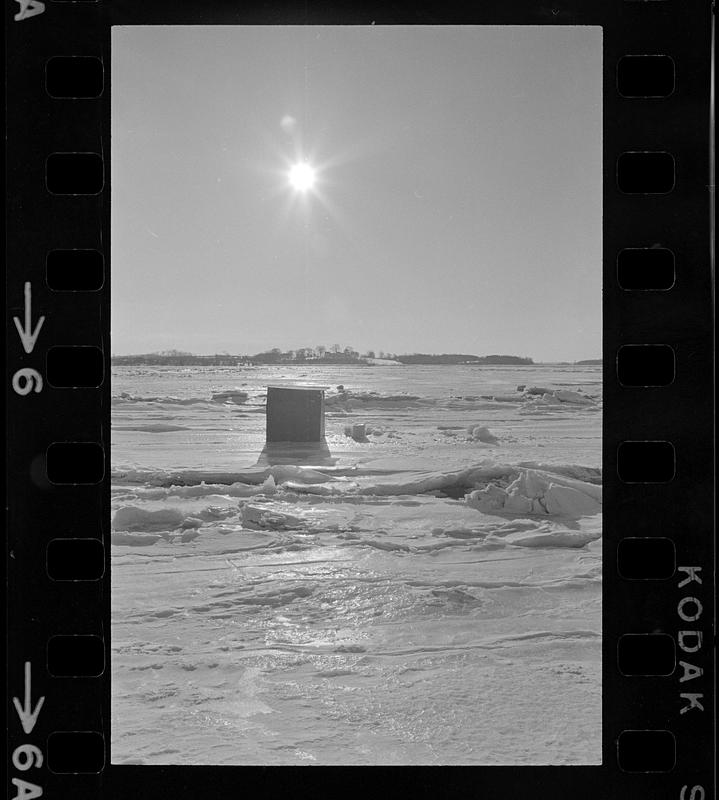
112, 26, 602, 361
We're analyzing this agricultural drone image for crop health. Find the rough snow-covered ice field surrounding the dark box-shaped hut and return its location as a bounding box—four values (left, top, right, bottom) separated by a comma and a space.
110, 365, 602, 765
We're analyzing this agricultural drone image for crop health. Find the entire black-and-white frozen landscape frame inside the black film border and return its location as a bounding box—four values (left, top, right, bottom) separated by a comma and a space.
110, 25, 602, 766
